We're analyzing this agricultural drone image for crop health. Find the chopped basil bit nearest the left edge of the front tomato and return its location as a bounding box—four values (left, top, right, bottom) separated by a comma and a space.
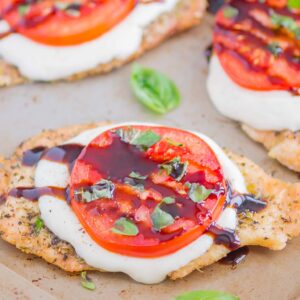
74, 179, 115, 203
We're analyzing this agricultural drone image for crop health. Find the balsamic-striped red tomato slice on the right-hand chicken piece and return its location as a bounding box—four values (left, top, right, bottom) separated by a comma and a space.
214, 0, 300, 90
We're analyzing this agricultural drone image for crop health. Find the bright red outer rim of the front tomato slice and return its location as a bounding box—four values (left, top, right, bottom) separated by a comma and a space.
71, 126, 227, 258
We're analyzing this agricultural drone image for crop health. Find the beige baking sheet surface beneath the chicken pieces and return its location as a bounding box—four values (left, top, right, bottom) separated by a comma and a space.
0, 17, 300, 300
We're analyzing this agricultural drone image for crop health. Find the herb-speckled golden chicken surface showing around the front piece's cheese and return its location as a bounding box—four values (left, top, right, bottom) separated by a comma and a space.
0, 123, 300, 279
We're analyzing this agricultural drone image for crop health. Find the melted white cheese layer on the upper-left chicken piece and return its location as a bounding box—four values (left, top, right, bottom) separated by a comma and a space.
0, 0, 178, 81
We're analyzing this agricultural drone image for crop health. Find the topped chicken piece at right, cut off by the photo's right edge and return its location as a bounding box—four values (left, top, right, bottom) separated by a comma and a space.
207, 0, 300, 171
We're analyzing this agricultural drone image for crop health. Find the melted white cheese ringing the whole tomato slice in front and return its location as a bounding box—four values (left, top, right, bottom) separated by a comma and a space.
35, 123, 247, 284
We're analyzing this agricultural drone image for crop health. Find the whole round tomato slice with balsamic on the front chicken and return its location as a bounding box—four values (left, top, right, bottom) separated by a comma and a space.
70, 126, 227, 257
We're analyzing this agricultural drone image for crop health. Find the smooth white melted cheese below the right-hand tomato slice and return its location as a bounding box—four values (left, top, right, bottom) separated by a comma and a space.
207, 56, 300, 131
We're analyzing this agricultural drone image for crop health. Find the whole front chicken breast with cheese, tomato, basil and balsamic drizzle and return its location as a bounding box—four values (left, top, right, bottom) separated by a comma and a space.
0, 123, 300, 284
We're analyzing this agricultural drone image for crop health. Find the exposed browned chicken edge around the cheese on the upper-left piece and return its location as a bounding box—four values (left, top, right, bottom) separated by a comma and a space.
0, 0, 207, 87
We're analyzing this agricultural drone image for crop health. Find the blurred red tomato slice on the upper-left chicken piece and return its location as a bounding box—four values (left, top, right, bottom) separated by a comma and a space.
0, 0, 136, 46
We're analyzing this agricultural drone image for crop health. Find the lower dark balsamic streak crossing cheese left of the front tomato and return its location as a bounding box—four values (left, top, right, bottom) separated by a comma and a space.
8, 187, 69, 202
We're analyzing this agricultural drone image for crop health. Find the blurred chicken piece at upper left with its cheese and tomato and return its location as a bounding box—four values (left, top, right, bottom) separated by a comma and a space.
0, 0, 206, 86
